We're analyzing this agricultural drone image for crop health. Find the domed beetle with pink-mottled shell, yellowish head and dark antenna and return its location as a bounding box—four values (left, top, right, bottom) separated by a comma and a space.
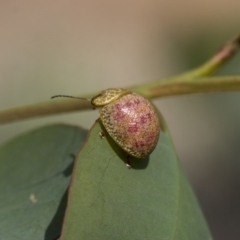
52, 88, 160, 158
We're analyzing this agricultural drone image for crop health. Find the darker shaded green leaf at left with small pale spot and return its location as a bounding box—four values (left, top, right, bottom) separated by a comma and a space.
0, 125, 87, 240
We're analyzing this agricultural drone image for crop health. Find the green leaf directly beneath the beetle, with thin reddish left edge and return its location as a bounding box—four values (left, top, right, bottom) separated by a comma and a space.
61, 123, 211, 240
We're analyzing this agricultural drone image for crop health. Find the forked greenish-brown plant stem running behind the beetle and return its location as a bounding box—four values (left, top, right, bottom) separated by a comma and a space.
0, 34, 240, 123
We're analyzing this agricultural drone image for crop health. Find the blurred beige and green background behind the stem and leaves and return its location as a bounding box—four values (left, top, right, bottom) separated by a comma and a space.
0, 0, 240, 240
